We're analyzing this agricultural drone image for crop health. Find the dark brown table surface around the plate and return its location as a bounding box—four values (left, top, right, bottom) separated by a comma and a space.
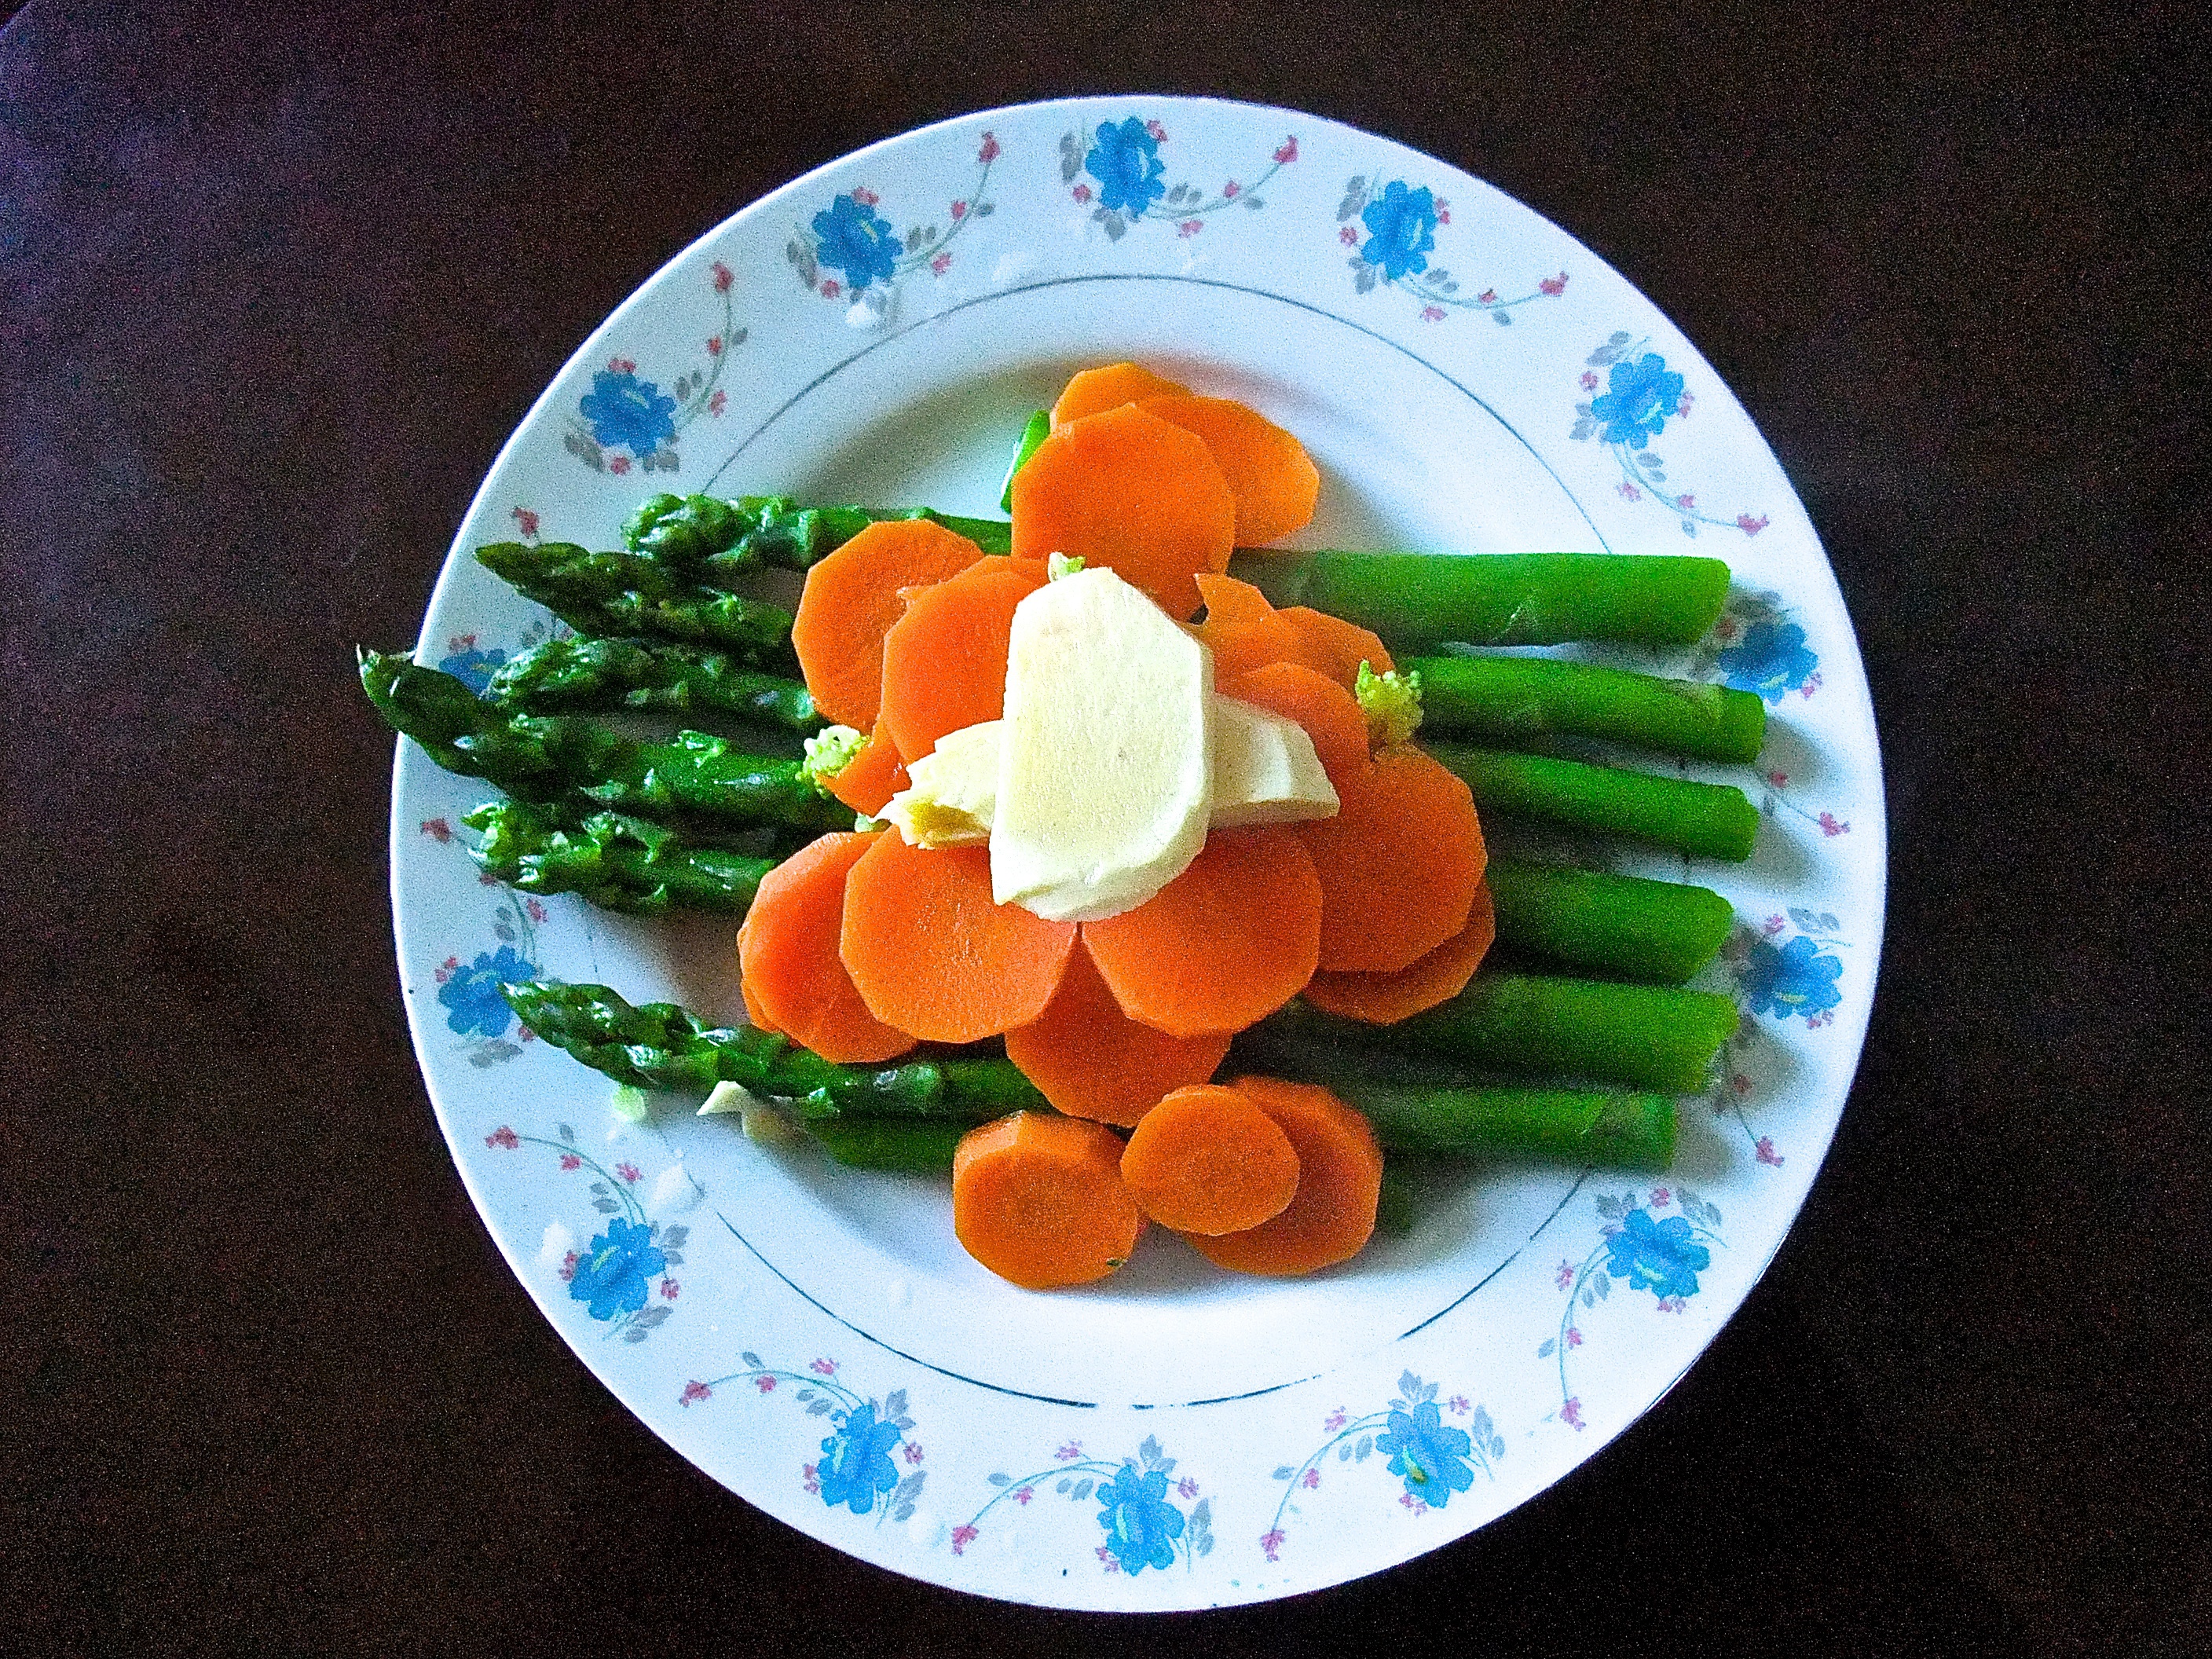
0, 0, 2212, 1654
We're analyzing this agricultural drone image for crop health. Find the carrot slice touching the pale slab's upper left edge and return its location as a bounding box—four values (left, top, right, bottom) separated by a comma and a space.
883, 559, 1044, 761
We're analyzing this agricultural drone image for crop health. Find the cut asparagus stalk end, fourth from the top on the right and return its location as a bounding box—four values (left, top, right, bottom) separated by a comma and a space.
1485, 859, 1737, 984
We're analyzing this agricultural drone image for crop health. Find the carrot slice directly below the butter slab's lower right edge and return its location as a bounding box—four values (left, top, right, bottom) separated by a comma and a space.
1084, 825, 1320, 1038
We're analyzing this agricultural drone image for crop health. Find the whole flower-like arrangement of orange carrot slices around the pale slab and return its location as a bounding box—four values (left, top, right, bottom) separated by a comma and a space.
739, 363, 1493, 1287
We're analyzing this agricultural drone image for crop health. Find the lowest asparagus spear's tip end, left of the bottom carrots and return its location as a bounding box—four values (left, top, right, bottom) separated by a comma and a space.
500, 980, 1046, 1124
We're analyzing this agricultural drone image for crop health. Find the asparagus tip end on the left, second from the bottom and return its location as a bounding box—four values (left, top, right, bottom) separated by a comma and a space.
463, 800, 776, 916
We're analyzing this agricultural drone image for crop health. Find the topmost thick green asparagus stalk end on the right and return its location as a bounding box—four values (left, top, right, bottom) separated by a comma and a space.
1276, 553, 1727, 653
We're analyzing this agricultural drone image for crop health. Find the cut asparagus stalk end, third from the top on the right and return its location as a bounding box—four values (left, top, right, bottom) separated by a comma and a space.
1426, 743, 1759, 862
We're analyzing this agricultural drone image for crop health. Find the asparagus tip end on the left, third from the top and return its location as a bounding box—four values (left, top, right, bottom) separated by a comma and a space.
485, 637, 830, 737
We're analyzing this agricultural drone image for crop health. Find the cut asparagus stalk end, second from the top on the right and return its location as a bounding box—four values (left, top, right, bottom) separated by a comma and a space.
1398, 657, 1767, 761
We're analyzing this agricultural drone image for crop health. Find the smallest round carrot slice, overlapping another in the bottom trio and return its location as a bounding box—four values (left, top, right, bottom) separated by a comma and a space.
1122, 1084, 1298, 1234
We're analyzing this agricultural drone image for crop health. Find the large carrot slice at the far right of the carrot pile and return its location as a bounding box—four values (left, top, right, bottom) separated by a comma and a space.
1296, 743, 1486, 973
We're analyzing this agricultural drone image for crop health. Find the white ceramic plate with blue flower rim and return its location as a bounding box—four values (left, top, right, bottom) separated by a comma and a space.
391, 97, 1882, 1610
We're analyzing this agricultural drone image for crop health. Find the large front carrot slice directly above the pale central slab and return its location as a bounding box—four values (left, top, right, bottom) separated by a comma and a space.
1013, 407, 1236, 621
